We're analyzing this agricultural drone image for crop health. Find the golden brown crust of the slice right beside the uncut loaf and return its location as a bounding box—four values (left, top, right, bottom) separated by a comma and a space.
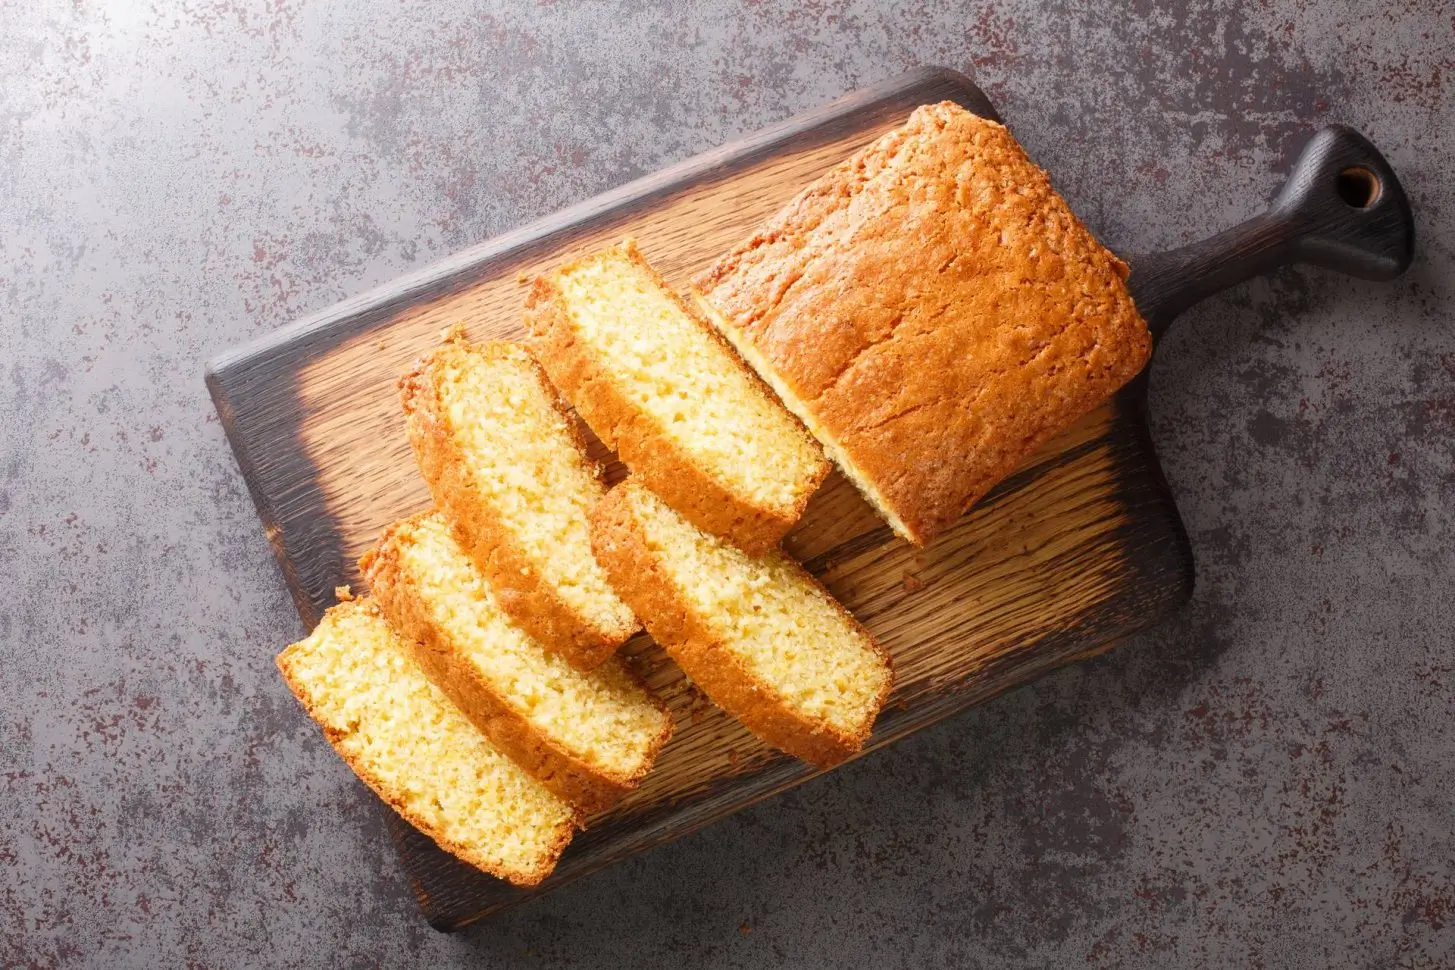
525, 239, 829, 556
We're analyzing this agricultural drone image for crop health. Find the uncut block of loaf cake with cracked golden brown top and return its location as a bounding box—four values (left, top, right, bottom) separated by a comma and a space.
694, 102, 1151, 545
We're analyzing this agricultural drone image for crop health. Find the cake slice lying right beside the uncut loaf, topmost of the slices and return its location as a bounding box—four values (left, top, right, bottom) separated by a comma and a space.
525, 240, 829, 553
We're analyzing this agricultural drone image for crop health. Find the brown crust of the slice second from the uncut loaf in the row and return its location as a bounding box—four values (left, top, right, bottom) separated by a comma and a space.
399, 332, 637, 670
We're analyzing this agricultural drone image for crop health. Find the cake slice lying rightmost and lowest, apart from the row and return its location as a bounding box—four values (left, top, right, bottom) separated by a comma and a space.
591, 480, 893, 768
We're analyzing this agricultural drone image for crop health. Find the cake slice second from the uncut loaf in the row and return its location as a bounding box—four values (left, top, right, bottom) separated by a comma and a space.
399, 329, 637, 670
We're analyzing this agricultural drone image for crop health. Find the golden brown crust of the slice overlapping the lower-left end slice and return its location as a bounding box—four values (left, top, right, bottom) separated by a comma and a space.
359, 512, 672, 814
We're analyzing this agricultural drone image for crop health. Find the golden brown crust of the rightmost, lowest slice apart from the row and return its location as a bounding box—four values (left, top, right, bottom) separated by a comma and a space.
591, 486, 892, 769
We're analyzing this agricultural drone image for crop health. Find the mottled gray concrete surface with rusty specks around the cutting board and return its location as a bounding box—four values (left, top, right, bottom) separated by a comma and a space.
0, 0, 1455, 969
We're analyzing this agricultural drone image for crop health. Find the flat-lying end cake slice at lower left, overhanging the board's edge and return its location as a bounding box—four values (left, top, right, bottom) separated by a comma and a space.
278, 599, 576, 886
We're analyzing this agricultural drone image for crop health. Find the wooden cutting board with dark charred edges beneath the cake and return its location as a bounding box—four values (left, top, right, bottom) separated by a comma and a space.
207, 70, 1392, 929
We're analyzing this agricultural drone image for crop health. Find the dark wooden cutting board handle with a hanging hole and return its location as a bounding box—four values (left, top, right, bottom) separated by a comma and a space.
1128, 125, 1414, 336
